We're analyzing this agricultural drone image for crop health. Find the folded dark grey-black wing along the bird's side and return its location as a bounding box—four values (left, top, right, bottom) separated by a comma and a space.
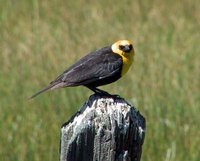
51, 51, 122, 88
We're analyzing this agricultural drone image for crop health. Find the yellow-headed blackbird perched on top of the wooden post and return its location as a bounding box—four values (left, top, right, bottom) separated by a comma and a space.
31, 40, 135, 98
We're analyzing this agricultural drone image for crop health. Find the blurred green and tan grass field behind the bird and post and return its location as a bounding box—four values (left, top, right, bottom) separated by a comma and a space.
0, 0, 200, 161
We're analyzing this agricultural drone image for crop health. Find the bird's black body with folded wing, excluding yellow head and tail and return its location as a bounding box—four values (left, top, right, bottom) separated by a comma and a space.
50, 46, 123, 87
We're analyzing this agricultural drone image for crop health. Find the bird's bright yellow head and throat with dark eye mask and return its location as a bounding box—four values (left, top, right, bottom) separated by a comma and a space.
111, 40, 135, 76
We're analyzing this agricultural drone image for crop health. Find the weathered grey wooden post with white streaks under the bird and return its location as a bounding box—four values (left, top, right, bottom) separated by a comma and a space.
60, 94, 145, 161
